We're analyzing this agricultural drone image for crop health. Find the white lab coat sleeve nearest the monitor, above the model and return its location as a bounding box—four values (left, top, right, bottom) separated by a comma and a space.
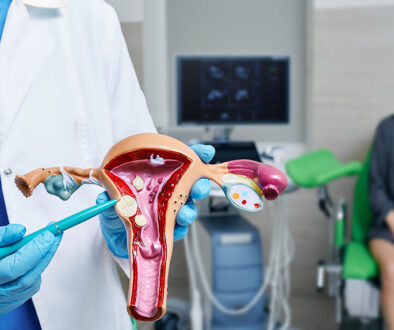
104, 5, 156, 142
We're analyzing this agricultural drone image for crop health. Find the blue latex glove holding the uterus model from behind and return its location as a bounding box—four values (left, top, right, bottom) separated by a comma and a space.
96, 144, 215, 258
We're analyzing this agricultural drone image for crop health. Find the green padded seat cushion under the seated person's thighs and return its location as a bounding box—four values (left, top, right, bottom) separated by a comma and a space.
343, 242, 379, 279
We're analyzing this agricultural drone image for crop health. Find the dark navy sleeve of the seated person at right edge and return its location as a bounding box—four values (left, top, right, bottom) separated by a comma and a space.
369, 121, 394, 226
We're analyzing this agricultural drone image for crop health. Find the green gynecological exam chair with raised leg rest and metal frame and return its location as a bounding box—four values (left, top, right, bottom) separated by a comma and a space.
286, 149, 381, 329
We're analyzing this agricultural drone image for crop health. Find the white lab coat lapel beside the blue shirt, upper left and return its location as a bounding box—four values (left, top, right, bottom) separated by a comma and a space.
0, 0, 56, 140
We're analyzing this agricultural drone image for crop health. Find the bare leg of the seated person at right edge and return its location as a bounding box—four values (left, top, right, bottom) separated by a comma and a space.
369, 239, 394, 330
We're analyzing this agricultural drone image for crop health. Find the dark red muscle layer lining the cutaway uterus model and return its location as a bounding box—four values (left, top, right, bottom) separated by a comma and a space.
104, 149, 191, 321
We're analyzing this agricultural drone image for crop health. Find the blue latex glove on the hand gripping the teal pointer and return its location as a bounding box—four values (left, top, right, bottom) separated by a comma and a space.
0, 224, 62, 314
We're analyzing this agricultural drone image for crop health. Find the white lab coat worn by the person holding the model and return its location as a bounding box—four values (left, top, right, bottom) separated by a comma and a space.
0, 0, 155, 330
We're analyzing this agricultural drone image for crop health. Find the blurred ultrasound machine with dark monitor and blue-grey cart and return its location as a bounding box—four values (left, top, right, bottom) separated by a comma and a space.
156, 56, 290, 330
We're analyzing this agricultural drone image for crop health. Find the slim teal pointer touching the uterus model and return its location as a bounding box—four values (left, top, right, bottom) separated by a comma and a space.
0, 199, 117, 259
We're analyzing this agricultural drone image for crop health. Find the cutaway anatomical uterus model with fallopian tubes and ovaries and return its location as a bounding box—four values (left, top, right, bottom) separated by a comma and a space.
15, 133, 286, 321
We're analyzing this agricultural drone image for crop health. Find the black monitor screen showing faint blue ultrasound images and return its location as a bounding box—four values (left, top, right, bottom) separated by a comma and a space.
177, 57, 289, 124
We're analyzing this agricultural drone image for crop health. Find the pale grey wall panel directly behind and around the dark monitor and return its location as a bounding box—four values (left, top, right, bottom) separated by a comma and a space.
144, 0, 312, 143
